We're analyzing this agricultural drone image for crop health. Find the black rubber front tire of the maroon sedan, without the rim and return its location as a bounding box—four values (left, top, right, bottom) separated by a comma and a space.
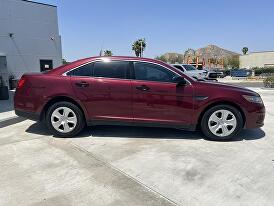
201, 104, 243, 140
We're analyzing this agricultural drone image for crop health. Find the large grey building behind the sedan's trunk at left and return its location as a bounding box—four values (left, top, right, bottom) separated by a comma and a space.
0, 0, 62, 86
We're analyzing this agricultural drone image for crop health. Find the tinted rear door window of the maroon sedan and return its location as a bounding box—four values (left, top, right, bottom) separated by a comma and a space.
93, 61, 130, 79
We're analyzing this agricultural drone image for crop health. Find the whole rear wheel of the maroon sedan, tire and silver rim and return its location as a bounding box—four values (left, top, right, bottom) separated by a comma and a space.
46, 102, 85, 137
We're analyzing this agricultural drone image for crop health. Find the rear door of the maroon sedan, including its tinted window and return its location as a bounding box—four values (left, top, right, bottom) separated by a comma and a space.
71, 61, 133, 123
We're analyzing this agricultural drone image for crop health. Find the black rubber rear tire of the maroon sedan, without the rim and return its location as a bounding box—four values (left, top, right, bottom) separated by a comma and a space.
45, 101, 86, 137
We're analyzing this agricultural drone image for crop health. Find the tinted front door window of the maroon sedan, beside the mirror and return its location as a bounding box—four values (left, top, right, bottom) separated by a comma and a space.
134, 62, 178, 82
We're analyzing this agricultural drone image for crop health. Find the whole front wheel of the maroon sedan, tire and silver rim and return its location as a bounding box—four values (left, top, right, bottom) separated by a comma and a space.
201, 105, 243, 140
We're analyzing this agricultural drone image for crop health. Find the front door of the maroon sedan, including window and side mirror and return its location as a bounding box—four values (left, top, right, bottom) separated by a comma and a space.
132, 62, 193, 127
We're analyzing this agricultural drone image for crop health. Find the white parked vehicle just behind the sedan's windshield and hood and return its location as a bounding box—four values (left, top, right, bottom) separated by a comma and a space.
172, 64, 207, 79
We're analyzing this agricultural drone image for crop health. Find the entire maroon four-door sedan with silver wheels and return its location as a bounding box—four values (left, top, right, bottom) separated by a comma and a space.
14, 57, 265, 140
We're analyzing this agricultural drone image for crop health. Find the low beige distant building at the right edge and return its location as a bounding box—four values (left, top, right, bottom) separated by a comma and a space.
240, 51, 274, 69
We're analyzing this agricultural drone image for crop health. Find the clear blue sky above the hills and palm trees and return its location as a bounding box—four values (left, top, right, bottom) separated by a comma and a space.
40, 0, 274, 61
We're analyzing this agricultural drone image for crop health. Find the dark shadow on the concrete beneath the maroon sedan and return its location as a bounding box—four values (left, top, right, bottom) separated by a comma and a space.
26, 123, 265, 141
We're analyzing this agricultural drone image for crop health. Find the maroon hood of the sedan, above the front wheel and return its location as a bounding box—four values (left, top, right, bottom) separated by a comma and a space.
199, 81, 260, 96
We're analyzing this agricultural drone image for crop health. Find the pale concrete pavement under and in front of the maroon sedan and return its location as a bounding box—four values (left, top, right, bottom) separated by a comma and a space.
0, 87, 274, 206
